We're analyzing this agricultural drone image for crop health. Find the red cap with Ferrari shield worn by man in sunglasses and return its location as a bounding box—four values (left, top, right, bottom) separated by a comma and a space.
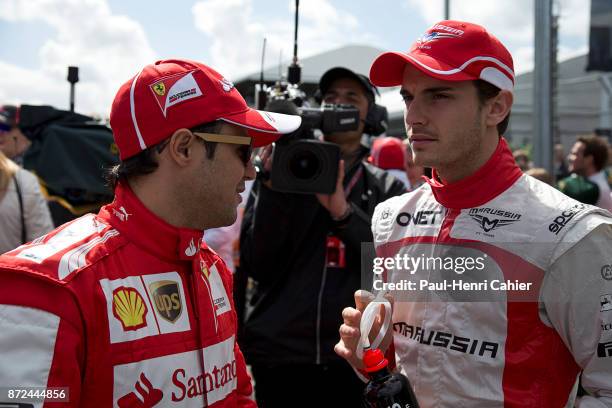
110, 60, 302, 160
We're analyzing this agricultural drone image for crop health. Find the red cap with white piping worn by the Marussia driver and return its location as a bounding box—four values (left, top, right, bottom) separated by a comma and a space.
370, 20, 514, 91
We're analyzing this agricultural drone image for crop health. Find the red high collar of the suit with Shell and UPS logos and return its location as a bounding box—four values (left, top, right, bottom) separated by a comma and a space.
100, 182, 207, 262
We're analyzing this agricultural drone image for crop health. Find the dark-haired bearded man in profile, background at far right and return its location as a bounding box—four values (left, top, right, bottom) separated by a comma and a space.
567, 135, 612, 211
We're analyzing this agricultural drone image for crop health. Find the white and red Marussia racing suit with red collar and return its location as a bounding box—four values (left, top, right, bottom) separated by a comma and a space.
372, 139, 612, 408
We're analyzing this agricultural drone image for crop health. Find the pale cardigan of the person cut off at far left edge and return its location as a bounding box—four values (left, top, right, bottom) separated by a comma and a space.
0, 150, 53, 254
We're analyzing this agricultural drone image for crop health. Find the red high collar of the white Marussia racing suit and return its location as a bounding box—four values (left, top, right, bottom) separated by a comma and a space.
424, 137, 523, 209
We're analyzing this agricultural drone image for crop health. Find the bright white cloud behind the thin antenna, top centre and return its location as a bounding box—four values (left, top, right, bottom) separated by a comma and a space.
192, 0, 376, 78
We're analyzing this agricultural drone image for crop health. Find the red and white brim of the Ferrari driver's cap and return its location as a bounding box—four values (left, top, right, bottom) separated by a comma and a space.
220, 108, 302, 147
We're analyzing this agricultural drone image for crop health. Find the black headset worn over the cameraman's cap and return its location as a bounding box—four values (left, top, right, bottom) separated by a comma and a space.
314, 67, 388, 136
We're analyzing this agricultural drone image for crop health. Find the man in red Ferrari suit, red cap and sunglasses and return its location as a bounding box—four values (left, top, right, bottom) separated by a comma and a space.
0, 60, 300, 408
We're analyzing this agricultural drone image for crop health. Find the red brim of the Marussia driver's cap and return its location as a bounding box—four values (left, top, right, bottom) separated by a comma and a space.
370, 52, 477, 86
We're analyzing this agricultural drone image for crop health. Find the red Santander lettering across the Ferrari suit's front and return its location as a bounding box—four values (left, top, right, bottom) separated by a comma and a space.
172, 360, 238, 402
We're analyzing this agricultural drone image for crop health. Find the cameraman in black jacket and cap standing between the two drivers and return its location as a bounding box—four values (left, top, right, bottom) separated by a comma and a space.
240, 68, 405, 407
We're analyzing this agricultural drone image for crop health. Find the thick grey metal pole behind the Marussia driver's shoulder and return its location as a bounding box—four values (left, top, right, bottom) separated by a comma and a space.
533, 0, 554, 175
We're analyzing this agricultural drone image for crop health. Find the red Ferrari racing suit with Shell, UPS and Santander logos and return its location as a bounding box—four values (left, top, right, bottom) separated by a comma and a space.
0, 184, 256, 408
